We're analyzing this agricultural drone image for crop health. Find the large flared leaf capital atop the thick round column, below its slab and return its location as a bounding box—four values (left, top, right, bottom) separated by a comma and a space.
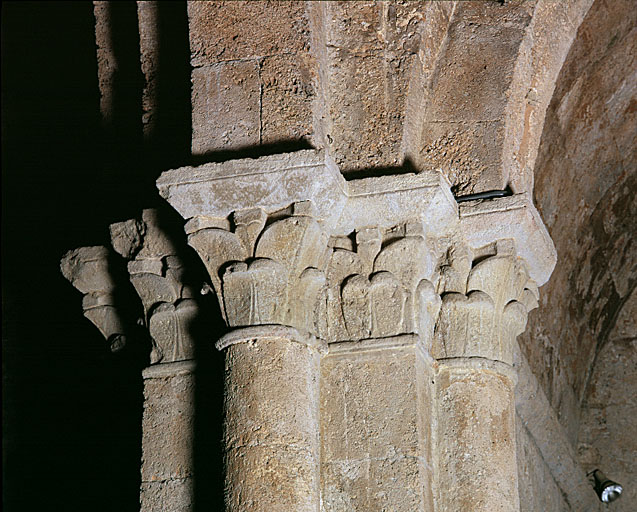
186, 201, 328, 334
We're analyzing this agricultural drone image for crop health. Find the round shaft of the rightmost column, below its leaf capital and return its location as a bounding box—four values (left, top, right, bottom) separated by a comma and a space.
436, 357, 520, 512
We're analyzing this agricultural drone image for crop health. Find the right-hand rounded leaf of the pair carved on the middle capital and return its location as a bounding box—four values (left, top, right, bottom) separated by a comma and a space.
370, 272, 407, 338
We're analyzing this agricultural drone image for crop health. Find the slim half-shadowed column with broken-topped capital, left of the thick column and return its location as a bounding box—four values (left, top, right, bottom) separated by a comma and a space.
110, 210, 200, 512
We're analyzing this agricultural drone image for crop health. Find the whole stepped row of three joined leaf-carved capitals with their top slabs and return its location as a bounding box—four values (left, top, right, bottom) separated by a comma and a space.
157, 150, 555, 352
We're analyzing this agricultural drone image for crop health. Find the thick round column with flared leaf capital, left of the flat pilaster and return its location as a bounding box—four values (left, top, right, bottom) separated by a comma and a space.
181, 202, 327, 512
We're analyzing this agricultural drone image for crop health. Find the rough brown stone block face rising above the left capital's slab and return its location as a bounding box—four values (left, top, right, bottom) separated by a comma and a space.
188, 1, 315, 155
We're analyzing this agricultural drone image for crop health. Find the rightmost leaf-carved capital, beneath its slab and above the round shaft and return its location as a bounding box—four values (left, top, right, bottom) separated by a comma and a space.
432, 240, 538, 364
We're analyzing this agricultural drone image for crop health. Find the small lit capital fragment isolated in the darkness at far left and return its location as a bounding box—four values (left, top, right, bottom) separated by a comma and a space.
60, 246, 126, 352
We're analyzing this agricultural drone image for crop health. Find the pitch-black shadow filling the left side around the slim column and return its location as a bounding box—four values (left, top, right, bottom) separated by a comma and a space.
2, 1, 222, 512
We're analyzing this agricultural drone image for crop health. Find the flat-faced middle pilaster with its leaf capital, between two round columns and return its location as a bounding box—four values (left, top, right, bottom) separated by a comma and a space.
321, 221, 440, 512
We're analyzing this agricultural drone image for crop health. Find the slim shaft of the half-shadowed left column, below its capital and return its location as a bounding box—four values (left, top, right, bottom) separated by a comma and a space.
140, 361, 195, 512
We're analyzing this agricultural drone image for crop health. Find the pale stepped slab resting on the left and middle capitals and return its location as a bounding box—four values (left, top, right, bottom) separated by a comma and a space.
156, 150, 458, 234
